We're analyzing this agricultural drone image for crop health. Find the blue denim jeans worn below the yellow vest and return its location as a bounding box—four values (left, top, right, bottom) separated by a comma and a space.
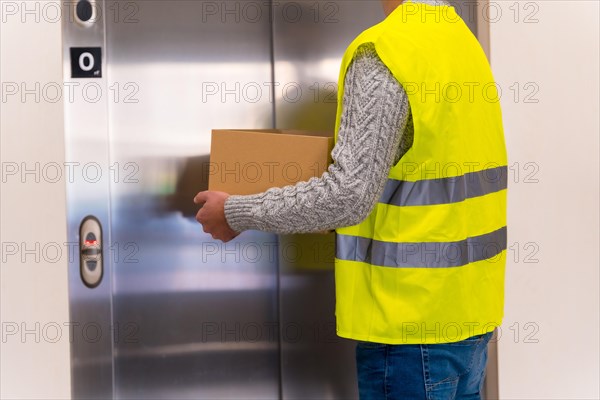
356, 332, 493, 400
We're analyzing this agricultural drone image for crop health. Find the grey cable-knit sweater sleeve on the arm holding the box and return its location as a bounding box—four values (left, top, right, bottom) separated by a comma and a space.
225, 44, 410, 234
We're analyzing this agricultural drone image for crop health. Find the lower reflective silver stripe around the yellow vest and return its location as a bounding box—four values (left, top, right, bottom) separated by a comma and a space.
335, 226, 506, 268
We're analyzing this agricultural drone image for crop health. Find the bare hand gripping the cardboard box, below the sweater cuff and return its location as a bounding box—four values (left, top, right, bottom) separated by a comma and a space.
194, 190, 239, 242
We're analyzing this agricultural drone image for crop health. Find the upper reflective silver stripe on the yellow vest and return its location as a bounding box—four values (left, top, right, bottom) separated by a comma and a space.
379, 166, 508, 206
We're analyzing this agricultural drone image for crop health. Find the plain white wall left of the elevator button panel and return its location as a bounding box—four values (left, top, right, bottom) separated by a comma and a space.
0, 0, 71, 399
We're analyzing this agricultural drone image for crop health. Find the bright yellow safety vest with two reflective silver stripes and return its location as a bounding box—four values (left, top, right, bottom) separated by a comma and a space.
335, 2, 507, 344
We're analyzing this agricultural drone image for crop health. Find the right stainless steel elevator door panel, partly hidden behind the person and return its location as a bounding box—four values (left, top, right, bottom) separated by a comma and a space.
273, 0, 476, 399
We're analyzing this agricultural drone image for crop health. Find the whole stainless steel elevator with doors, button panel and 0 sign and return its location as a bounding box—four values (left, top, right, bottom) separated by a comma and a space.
62, 0, 495, 399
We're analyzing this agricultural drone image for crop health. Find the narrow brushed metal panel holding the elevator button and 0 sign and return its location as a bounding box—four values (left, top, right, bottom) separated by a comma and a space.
62, 1, 113, 399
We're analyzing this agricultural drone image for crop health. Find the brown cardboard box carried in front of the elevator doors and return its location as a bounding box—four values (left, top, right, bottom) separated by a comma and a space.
208, 129, 333, 195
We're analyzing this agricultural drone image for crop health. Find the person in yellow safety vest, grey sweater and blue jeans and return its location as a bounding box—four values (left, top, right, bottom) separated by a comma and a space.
194, 0, 507, 399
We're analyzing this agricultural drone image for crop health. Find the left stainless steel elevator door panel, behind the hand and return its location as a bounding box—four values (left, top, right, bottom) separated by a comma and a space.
106, 1, 279, 399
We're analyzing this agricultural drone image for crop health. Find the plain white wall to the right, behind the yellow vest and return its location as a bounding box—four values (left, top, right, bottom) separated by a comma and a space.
490, 0, 600, 399
